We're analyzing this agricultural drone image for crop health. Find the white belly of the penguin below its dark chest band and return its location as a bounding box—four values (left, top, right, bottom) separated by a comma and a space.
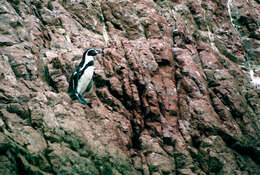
77, 66, 95, 94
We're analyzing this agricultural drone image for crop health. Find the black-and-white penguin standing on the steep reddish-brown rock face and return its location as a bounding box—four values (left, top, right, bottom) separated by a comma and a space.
68, 48, 104, 106
